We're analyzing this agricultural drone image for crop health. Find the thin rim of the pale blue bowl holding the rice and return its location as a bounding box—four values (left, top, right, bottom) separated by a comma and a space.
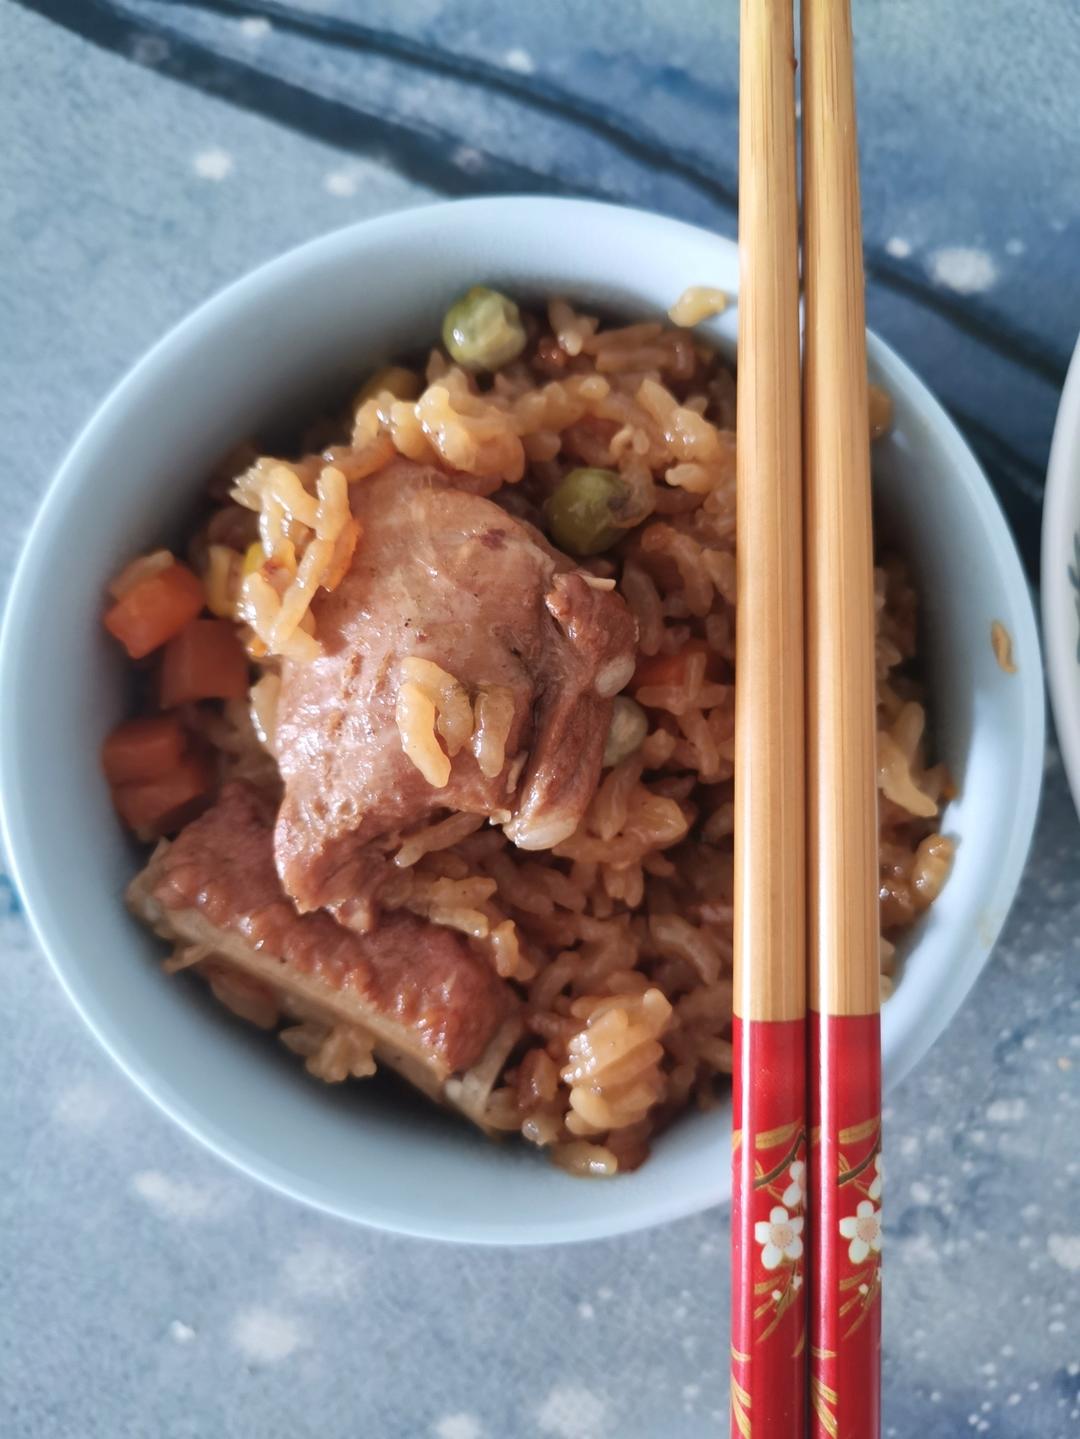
0, 196, 1046, 1245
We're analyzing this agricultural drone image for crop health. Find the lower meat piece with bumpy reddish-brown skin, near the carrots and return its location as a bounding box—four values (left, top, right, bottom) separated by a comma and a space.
128, 783, 521, 1107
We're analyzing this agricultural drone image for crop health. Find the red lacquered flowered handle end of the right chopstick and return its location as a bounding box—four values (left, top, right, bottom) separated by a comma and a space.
810, 1014, 882, 1439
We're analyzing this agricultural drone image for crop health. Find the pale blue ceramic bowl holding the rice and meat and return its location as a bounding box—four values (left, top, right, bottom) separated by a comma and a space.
0, 199, 1043, 1243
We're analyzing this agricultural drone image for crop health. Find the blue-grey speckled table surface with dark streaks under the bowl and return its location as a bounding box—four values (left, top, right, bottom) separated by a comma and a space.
0, 0, 1080, 1439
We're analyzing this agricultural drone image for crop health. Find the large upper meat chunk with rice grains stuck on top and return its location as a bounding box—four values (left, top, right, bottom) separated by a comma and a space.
275, 460, 637, 909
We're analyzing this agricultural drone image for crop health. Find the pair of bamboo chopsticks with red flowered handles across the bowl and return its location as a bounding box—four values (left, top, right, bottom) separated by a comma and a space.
731, 0, 882, 1439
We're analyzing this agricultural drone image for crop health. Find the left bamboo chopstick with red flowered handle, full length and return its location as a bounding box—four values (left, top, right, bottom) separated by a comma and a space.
731, 0, 807, 1439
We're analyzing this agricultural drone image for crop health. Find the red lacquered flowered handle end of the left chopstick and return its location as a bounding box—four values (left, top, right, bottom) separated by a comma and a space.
731, 1014, 807, 1439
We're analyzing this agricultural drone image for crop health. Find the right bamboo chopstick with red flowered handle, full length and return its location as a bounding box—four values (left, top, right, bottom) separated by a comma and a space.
802, 0, 882, 1439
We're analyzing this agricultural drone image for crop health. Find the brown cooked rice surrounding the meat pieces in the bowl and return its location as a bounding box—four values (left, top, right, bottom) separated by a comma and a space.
99, 292, 952, 1174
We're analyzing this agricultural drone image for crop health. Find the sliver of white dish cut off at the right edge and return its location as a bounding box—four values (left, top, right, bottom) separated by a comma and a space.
1043, 329, 1080, 813
